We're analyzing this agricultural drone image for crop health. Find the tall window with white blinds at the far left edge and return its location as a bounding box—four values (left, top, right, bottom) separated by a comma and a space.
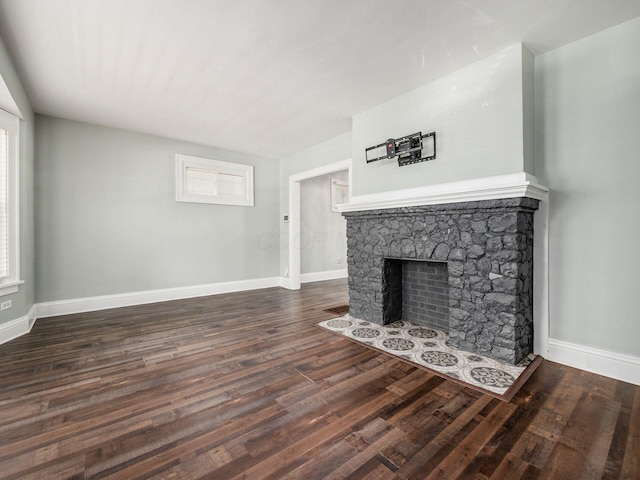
0, 110, 23, 296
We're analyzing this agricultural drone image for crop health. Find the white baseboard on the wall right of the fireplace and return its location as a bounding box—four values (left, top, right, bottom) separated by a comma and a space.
547, 339, 640, 385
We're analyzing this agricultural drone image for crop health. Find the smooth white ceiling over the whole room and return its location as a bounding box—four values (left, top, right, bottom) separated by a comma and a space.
0, 0, 640, 158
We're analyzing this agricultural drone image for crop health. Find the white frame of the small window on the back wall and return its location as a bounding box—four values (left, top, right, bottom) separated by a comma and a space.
176, 154, 254, 207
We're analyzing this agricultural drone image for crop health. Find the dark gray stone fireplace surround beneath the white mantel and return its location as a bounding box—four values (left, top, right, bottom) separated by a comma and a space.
343, 197, 538, 364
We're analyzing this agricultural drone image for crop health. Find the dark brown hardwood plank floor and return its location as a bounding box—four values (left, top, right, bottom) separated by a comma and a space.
0, 281, 640, 480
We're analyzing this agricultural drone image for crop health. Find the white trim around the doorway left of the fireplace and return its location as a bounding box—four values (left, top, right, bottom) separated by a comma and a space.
286, 158, 353, 290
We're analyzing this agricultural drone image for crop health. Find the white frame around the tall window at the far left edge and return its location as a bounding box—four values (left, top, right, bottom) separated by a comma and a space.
0, 109, 24, 296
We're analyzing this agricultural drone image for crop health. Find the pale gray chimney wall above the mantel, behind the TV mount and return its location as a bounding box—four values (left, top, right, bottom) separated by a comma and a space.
352, 44, 534, 196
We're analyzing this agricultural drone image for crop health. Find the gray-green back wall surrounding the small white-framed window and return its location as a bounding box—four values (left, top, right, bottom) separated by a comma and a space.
36, 116, 279, 302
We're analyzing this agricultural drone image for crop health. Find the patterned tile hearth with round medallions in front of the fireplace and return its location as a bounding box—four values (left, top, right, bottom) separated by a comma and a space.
317, 315, 539, 400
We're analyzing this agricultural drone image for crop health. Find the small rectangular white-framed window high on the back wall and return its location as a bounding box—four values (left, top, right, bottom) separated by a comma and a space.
176, 154, 253, 207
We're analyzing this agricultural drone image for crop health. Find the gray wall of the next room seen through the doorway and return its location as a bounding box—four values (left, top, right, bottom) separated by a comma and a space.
300, 170, 349, 273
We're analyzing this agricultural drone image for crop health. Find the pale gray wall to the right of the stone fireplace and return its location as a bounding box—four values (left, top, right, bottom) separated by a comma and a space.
536, 19, 640, 356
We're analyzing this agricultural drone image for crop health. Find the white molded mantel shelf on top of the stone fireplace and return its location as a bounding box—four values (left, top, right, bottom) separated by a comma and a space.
338, 172, 549, 212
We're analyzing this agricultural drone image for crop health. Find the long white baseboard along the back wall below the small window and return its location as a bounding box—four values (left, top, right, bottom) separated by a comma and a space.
36, 277, 283, 318
